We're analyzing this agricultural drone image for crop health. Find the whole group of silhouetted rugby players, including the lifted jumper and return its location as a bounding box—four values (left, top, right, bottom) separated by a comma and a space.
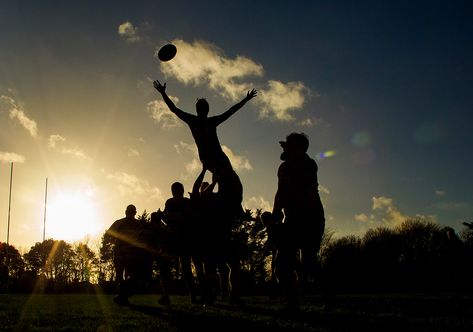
107, 81, 325, 308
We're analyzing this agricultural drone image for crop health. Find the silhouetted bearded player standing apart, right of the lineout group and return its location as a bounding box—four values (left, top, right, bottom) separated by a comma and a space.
272, 133, 325, 308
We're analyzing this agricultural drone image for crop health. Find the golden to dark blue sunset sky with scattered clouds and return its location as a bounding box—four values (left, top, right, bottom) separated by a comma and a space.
0, 0, 473, 251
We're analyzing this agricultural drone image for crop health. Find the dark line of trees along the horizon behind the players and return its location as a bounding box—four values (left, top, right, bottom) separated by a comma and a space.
0, 210, 473, 294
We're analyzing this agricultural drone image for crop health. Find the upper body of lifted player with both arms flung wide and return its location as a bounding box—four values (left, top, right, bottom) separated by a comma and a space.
153, 80, 257, 173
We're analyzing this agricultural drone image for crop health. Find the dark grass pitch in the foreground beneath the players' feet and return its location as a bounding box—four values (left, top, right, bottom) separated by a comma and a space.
0, 294, 473, 332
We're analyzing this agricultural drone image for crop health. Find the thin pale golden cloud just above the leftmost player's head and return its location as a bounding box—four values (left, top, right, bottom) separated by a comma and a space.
106, 172, 163, 199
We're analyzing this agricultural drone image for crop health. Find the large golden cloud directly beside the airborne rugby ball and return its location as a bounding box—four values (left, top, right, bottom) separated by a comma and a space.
155, 39, 263, 101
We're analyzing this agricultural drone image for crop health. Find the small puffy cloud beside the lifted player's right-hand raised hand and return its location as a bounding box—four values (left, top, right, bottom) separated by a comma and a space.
258, 80, 309, 122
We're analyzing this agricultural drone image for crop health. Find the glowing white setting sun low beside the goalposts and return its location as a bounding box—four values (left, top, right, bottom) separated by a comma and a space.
45, 192, 101, 242
